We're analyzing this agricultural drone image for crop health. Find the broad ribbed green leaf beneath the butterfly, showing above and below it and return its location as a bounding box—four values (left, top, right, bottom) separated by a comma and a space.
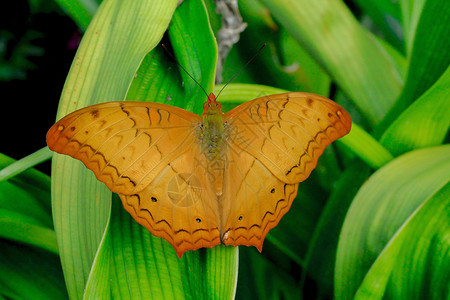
85, 1, 238, 299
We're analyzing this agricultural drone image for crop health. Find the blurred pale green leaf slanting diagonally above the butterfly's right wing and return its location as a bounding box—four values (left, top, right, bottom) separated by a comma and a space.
262, 0, 402, 125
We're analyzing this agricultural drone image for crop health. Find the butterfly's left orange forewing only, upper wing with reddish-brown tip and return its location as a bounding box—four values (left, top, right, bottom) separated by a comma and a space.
47, 102, 201, 194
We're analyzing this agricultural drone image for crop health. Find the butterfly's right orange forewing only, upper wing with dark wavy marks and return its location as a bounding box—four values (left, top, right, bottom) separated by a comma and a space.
225, 93, 351, 184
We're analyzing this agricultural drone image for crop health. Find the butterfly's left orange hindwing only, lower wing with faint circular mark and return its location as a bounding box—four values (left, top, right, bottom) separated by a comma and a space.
119, 145, 220, 257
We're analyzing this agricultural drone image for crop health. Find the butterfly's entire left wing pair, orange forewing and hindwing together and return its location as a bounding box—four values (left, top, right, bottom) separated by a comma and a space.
47, 101, 220, 256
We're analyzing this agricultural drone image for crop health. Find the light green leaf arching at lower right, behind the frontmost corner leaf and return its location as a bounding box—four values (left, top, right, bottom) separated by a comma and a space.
335, 145, 450, 299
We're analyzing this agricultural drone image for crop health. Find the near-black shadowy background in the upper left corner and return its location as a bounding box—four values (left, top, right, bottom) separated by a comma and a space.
0, 0, 78, 174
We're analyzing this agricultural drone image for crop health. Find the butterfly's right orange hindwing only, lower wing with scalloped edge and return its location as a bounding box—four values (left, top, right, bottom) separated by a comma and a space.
221, 152, 298, 251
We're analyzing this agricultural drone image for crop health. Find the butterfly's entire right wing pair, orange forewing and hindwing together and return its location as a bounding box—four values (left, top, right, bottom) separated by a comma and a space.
221, 93, 351, 250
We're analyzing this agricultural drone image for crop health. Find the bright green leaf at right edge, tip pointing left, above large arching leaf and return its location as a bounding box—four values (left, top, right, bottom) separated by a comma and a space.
381, 67, 450, 155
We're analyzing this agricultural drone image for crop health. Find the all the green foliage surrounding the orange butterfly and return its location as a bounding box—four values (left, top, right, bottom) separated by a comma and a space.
0, 0, 450, 299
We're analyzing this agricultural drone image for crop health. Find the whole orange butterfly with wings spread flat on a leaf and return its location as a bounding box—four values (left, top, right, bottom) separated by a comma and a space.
47, 92, 351, 257
